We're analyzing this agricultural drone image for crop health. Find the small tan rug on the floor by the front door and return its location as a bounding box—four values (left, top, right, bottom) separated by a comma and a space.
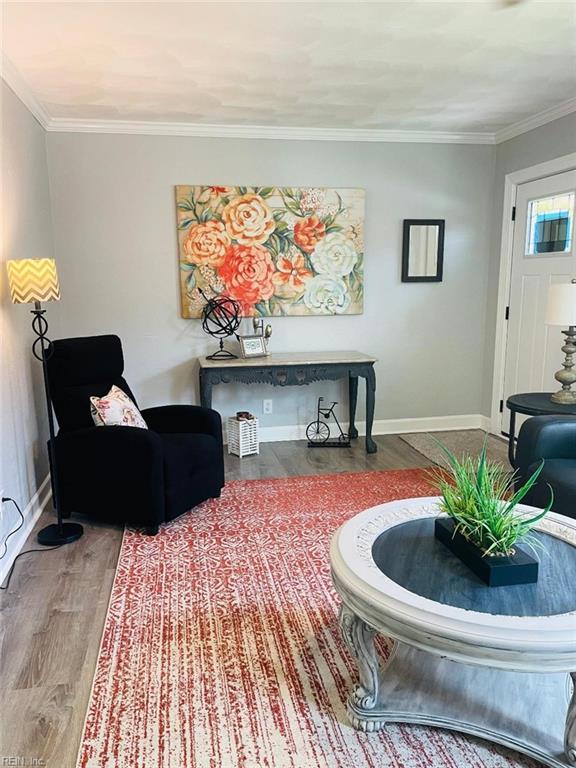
400, 429, 510, 469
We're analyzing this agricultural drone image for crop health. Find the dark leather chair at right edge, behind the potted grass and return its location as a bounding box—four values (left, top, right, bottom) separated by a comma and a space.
516, 416, 576, 518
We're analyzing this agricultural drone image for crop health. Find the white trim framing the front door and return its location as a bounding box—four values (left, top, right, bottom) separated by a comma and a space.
490, 152, 576, 435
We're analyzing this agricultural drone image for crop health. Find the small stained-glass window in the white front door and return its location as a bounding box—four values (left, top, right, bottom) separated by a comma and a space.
526, 192, 574, 256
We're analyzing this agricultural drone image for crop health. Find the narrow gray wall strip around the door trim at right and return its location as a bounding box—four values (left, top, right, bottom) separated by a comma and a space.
482, 113, 576, 414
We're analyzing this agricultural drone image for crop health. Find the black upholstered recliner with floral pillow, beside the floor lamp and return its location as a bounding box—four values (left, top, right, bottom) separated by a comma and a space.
48, 336, 224, 534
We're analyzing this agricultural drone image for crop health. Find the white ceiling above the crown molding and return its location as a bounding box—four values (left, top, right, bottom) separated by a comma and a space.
3, 0, 576, 132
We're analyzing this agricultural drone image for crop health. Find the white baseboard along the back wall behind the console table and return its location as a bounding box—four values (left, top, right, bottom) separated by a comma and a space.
224, 414, 490, 443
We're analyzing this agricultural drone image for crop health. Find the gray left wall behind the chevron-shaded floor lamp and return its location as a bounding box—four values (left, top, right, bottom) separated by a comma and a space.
0, 81, 58, 563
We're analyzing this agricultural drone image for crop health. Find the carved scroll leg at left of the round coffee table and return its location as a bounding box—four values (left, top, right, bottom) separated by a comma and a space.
338, 604, 385, 731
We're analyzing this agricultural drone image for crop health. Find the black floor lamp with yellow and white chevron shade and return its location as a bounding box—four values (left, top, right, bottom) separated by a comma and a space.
6, 259, 84, 547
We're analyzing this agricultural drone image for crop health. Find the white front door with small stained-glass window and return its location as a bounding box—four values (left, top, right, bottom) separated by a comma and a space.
501, 171, 576, 431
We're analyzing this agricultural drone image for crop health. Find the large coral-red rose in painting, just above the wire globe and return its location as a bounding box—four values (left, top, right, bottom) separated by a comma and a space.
218, 245, 274, 316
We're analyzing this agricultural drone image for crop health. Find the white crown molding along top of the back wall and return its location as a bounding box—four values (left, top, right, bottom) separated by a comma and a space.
46, 118, 494, 144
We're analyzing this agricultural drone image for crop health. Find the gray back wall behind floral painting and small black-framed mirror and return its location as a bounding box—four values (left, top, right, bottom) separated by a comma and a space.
47, 133, 494, 426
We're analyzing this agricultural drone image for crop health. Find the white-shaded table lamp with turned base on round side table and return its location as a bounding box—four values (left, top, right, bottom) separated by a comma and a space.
546, 280, 576, 405
